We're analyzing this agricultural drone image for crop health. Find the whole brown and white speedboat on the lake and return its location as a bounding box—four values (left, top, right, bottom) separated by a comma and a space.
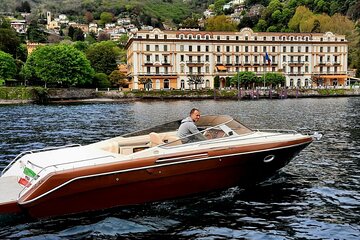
0, 115, 320, 218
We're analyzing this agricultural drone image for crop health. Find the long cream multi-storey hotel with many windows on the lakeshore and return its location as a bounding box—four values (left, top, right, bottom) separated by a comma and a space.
127, 28, 348, 89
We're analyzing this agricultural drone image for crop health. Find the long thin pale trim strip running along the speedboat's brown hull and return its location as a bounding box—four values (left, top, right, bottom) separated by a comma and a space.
18, 141, 311, 205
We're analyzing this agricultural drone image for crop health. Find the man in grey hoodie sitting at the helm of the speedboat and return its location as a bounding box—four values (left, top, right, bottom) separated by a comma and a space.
177, 108, 206, 143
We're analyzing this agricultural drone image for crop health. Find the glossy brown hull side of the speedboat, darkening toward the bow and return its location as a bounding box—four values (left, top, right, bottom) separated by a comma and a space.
19, 138, 312, 218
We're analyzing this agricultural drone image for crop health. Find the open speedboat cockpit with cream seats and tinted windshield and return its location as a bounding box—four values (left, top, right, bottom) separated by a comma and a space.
96, 115, 253, 155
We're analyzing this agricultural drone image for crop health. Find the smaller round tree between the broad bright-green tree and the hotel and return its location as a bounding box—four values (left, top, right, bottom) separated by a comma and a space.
86, 41, 120, 75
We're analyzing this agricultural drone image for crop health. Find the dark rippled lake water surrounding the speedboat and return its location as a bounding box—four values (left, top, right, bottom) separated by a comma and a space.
0, 97, 360, 239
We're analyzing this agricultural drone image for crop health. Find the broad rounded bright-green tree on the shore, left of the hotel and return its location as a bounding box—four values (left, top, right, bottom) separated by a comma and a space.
23, 44, 94, 86
